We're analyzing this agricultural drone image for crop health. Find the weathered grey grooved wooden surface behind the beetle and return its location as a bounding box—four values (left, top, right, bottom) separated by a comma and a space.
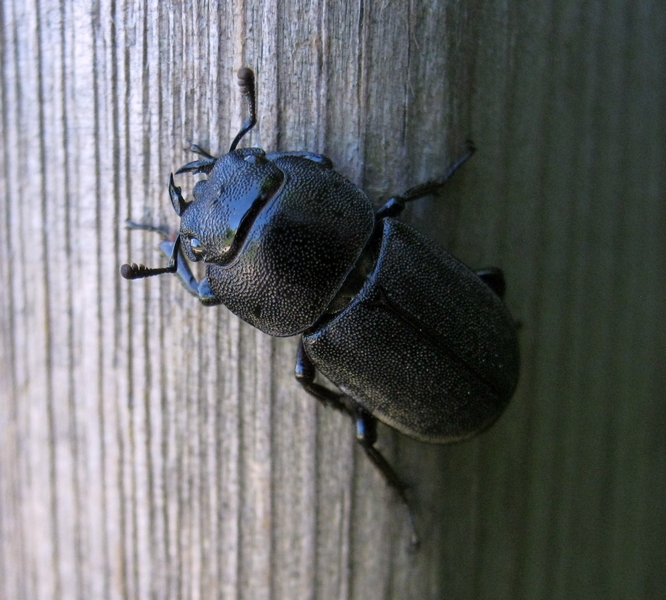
0, 0, 666, 600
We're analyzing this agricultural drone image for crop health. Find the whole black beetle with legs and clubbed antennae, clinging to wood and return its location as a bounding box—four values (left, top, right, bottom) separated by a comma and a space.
121, 68, 519, 548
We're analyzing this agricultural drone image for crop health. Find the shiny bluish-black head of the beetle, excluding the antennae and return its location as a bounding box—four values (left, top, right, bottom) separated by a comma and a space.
176, 148, 284, 264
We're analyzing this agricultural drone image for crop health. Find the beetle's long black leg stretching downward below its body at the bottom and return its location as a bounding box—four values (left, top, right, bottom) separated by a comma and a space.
294, 338, 419, 547
